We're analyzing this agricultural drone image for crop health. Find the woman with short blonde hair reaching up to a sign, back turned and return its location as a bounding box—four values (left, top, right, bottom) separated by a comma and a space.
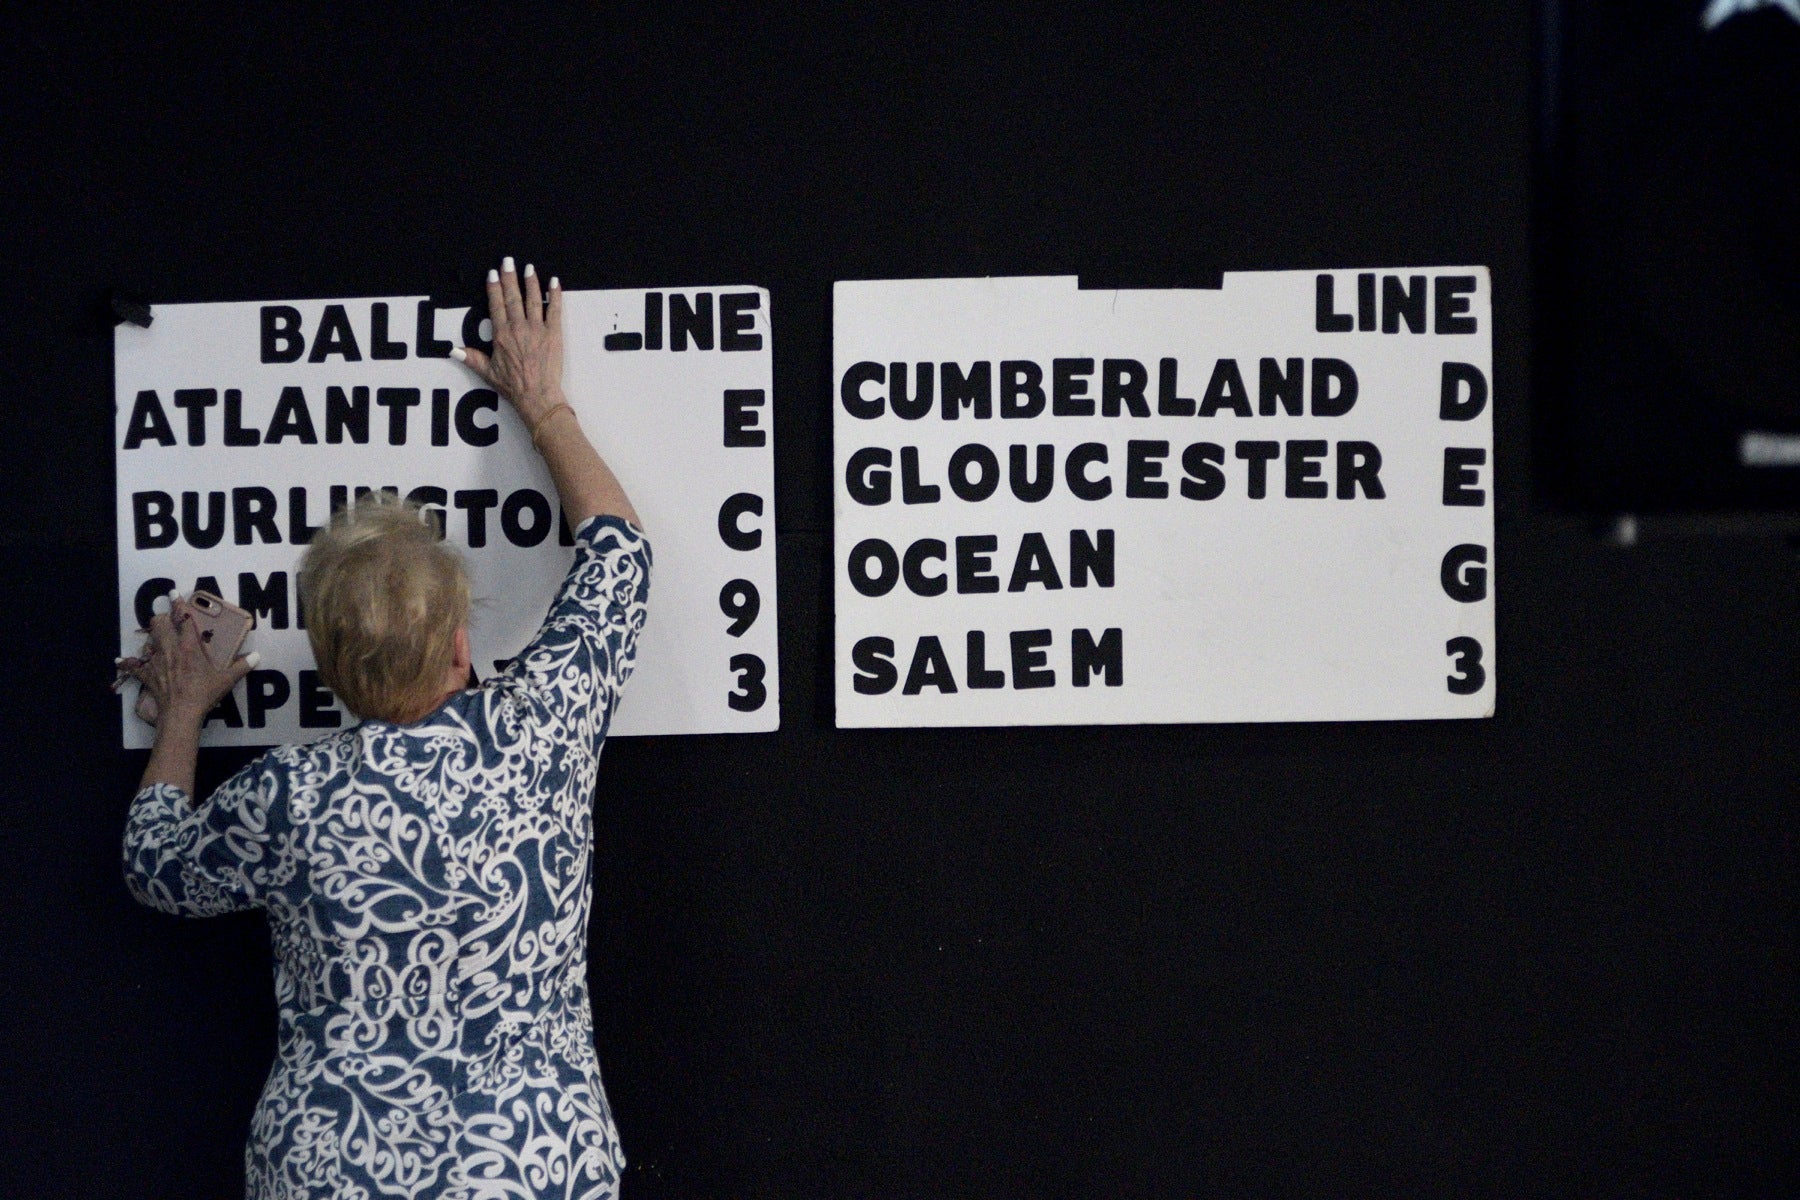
124, 259, 650, 1200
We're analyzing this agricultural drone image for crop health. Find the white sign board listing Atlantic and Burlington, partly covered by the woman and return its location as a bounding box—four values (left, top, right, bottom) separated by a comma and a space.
113, 288, 779, 748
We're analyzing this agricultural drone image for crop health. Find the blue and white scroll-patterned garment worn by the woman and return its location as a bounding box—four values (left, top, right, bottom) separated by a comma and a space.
124, 516, 650, 1200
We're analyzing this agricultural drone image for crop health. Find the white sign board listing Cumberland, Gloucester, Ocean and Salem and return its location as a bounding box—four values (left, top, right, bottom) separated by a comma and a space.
832, 268, 1494, 727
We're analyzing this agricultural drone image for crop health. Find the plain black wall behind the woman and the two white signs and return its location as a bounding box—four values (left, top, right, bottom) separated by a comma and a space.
0, 2, 1800, 1198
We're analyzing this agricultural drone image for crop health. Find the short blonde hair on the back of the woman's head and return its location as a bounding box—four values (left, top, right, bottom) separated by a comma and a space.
299, 491, 468, 721
